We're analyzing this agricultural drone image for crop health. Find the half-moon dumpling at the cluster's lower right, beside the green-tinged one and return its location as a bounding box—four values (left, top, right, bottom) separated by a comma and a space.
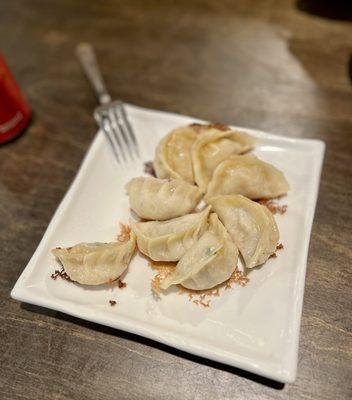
209, 195, 279, 268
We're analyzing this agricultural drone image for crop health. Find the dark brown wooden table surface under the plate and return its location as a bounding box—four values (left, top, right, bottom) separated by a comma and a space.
0, 0, 352, 400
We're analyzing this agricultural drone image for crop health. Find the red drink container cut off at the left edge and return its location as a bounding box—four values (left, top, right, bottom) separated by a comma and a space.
0, 54, 31, 144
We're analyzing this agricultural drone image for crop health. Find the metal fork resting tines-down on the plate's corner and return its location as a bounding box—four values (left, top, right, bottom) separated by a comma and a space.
76, 43, 139, 164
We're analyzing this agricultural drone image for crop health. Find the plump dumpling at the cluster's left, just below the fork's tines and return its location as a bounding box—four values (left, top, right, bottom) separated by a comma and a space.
125, 178, 202, 220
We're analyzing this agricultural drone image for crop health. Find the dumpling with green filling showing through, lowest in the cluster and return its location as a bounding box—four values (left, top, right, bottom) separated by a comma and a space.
160, 213, 238, 290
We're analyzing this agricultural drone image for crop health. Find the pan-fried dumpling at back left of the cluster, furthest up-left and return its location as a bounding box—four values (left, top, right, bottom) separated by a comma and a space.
154, 126, 198, 183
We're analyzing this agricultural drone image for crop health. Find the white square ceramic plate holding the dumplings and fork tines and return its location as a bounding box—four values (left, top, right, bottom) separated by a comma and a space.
11, 106, 325, 382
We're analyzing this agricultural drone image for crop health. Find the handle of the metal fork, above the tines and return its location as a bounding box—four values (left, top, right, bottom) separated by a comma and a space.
76, 43, 111, 104
